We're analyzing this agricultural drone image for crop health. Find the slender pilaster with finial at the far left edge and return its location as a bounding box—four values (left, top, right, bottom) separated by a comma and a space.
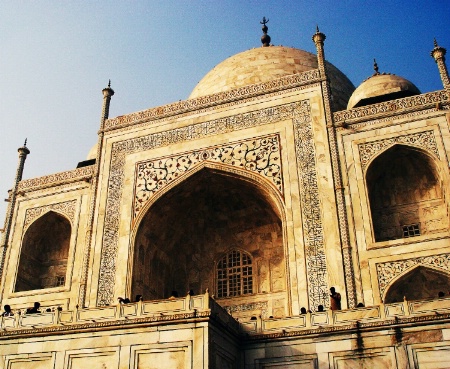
0, 140, 30, 281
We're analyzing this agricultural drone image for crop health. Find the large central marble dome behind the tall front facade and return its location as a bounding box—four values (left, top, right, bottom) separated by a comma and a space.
189, 46, 355, 107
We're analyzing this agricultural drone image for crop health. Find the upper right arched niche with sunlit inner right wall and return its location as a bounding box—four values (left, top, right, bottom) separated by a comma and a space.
366, 145, 448, 242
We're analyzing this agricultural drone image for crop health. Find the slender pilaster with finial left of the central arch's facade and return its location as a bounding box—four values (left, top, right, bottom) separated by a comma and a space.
78, 81, 114, 307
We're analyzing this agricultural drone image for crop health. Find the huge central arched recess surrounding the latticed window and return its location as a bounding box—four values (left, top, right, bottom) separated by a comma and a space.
131, 167, 286, 299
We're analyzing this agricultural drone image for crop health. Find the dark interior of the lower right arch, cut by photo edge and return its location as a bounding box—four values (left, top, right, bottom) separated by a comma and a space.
385, 266, 450, 304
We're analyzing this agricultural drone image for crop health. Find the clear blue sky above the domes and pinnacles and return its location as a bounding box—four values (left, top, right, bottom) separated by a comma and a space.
0, 0, 450, 218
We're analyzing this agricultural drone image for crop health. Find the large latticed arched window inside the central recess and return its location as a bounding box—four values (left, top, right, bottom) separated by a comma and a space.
217, 250, 253, 297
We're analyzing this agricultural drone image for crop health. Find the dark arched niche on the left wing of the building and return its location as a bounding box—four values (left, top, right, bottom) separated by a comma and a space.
15, 212, 71, 292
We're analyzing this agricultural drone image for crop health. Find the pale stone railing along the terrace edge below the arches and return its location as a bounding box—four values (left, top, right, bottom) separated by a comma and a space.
0, 292, 450, 337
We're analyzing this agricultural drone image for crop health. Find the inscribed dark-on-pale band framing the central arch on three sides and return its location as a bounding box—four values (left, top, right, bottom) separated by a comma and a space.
97, 100, 328, 306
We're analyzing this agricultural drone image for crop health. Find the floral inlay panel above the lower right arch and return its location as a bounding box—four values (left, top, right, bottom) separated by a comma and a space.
376, 254, 450, 298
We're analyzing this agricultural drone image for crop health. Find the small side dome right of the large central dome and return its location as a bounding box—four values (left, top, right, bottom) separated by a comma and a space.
347, 73, 420, 109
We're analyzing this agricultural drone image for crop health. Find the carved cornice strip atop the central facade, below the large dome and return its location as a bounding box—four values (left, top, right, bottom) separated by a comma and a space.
104, 69, 324, 132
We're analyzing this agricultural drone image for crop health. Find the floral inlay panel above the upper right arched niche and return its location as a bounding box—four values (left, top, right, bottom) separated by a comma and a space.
358, 131, 439, 170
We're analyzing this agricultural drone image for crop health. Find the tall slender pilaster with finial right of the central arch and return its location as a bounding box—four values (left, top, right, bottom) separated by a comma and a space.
312, 27, 356, 308
